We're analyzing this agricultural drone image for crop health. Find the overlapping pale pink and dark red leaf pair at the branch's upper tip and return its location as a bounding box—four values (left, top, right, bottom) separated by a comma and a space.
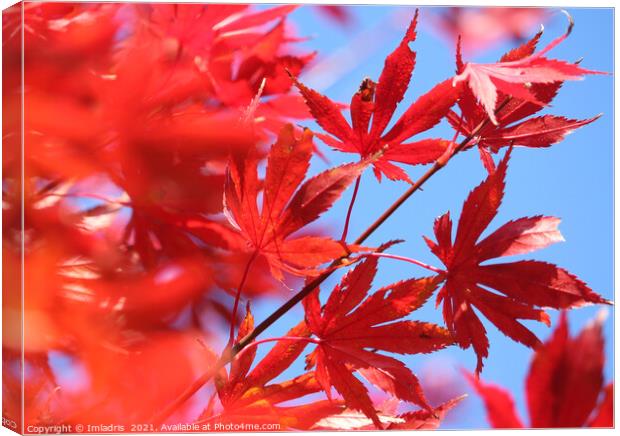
448, 21, 600, 171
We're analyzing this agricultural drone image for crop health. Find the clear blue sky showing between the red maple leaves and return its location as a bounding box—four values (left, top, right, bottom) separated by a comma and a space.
249, 6, 613, 428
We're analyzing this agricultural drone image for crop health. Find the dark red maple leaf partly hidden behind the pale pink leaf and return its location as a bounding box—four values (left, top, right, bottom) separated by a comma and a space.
447, 24, 600, 172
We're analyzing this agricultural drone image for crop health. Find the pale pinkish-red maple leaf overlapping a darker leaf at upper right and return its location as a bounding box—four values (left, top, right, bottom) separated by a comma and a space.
453, 16, 604, 125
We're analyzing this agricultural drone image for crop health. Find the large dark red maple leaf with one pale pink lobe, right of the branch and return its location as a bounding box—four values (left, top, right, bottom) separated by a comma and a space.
425, 151, 608, 372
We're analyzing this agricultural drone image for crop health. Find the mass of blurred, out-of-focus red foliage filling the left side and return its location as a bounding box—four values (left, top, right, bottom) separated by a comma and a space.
3, 3, 313, 430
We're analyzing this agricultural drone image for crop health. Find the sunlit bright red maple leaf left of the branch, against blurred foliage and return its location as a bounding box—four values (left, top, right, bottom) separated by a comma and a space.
224, 125, 367, 279
